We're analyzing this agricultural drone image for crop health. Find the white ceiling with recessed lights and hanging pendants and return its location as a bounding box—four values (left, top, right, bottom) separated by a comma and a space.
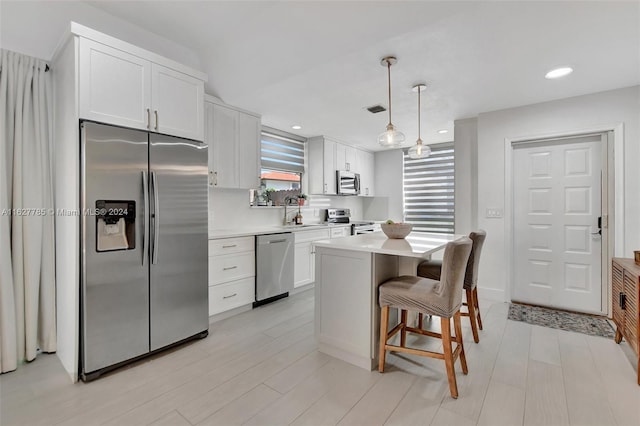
88, 0, 640, 150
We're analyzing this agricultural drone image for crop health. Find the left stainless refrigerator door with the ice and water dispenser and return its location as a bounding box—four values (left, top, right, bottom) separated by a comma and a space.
78, 122, 149, 374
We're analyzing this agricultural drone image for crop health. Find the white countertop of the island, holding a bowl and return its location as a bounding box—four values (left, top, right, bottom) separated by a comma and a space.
313, 231, 464, 258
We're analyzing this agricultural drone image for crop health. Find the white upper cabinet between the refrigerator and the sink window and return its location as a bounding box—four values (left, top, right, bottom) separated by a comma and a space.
205, 101, 262, 189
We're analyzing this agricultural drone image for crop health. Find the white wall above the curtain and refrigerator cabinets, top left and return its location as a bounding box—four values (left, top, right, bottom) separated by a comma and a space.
0, 0, 202, 69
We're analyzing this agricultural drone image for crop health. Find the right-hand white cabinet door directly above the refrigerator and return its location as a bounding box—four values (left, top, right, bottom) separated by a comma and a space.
151, 64, 204, 141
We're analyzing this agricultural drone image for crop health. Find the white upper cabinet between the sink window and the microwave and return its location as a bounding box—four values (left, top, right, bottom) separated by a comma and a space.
307, 136, 338, 195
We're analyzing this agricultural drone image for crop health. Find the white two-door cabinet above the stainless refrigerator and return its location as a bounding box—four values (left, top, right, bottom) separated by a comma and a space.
79, 36, 204, 140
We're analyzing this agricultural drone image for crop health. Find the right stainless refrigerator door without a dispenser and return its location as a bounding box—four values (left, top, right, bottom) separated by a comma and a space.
149, 133, 209, 350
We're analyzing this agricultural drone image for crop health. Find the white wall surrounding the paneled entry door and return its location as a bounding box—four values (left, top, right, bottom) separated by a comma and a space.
472, 86, 640, 299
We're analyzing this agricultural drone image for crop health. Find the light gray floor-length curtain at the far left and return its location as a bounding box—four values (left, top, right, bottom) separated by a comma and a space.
0, 49, 56, 373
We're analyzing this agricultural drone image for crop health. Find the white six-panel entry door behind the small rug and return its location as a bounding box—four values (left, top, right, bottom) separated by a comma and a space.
512, 135, 605, 313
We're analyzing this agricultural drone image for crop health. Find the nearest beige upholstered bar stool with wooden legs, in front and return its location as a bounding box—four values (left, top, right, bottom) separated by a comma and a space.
378, 237, 471, 398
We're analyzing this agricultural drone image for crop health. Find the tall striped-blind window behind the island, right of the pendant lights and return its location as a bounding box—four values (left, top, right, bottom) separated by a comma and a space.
403, 142, 455, 234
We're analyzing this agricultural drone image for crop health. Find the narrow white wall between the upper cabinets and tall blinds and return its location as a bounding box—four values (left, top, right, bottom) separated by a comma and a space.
367, 149, 404, 222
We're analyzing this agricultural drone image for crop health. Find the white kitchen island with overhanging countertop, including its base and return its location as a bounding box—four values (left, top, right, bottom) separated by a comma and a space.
314, 232, 462, 370
